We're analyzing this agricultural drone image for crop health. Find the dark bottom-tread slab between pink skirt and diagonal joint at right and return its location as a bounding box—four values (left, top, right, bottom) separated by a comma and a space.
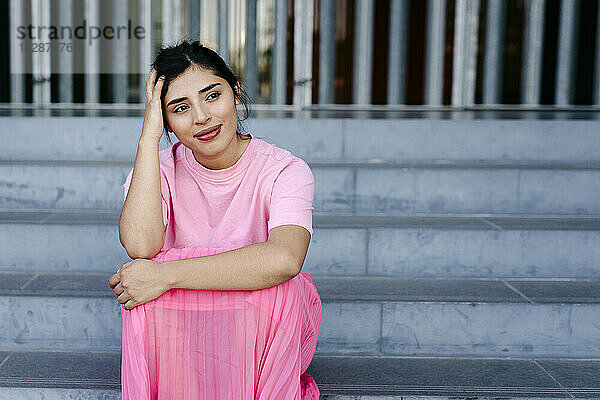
307, 356, 568, 398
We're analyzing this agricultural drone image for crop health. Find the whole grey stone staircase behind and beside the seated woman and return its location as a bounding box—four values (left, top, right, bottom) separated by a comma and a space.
0, 117, 600, 400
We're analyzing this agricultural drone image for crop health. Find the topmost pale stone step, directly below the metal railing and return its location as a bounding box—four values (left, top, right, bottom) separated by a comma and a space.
0, 115, 600, 162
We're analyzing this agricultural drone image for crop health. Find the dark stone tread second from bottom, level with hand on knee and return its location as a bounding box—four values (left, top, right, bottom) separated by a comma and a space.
0, 270, 600, 304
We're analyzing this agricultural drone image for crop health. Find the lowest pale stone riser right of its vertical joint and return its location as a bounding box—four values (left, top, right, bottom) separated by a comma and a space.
381, 302, 600, 358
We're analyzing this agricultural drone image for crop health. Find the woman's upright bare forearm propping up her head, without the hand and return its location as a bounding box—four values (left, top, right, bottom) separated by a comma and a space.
119, 135, 165, 258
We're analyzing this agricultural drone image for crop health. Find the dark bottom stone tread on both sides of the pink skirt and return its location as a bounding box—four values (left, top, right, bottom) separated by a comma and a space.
0, 351, 600, 400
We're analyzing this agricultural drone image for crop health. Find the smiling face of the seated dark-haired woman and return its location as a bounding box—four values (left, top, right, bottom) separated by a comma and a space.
163, 66, 243, 169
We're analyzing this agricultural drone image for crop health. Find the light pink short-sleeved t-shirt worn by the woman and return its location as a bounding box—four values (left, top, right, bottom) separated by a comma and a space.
123, 137, 314, 249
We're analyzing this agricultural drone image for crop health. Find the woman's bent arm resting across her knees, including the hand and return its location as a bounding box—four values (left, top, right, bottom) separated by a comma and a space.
108, 225, 311, 310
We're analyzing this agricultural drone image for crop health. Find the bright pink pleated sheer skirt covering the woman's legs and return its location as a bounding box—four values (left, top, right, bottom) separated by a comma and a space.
121, 247, 321, 400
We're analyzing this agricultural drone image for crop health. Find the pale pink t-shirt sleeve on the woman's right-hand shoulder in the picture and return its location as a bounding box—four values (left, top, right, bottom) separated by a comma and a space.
267, 158, 315, 236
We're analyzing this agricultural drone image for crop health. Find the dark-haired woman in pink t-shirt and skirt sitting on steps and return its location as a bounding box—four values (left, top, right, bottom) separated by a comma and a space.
109, 41, 321, 400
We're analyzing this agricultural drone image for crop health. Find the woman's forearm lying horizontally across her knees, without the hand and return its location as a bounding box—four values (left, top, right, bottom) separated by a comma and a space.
162, 242, 294, 290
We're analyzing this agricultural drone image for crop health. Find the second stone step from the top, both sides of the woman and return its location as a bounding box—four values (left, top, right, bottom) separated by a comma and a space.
0, 159, 600, 214
